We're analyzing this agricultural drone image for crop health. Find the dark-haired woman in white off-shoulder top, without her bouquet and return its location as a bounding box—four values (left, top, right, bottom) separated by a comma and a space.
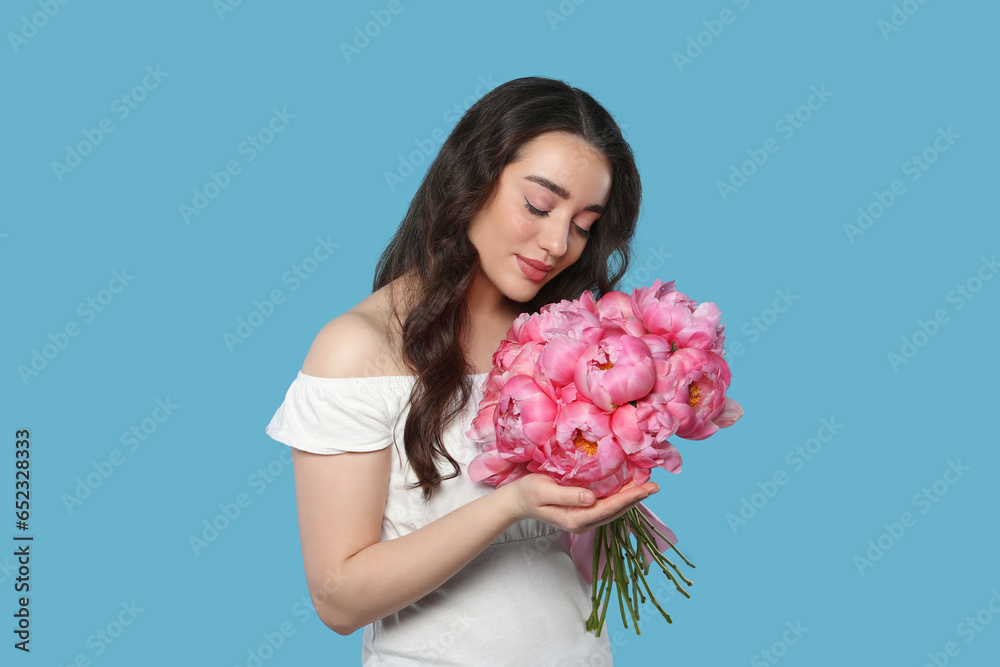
266, 77, 658, 665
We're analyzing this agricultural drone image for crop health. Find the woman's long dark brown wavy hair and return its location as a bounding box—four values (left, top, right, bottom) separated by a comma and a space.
372, 77, 642, 500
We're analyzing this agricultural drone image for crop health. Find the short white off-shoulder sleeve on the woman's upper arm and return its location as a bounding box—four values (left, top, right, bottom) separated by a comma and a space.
264, 371, 393, 454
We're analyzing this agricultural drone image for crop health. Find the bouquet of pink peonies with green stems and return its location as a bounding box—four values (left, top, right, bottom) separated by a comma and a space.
467, 280, 743, 636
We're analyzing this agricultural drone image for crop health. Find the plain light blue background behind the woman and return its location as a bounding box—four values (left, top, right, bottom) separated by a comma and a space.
0, 0, 1000, 667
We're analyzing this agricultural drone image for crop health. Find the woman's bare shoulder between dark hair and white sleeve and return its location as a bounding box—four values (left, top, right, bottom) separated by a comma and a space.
302, 280, 408, 377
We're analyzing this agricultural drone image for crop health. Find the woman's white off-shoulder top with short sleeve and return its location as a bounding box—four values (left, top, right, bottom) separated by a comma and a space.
265, 371, 613, 667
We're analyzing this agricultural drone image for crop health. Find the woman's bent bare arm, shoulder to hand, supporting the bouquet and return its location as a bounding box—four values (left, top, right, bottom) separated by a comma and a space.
292, 318, 657, 634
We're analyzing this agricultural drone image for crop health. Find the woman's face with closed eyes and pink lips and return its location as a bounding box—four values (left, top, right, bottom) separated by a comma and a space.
468, 132, 611, 302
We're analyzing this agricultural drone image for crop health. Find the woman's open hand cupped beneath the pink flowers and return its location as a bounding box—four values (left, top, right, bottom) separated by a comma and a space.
497, 473, 660, 535
